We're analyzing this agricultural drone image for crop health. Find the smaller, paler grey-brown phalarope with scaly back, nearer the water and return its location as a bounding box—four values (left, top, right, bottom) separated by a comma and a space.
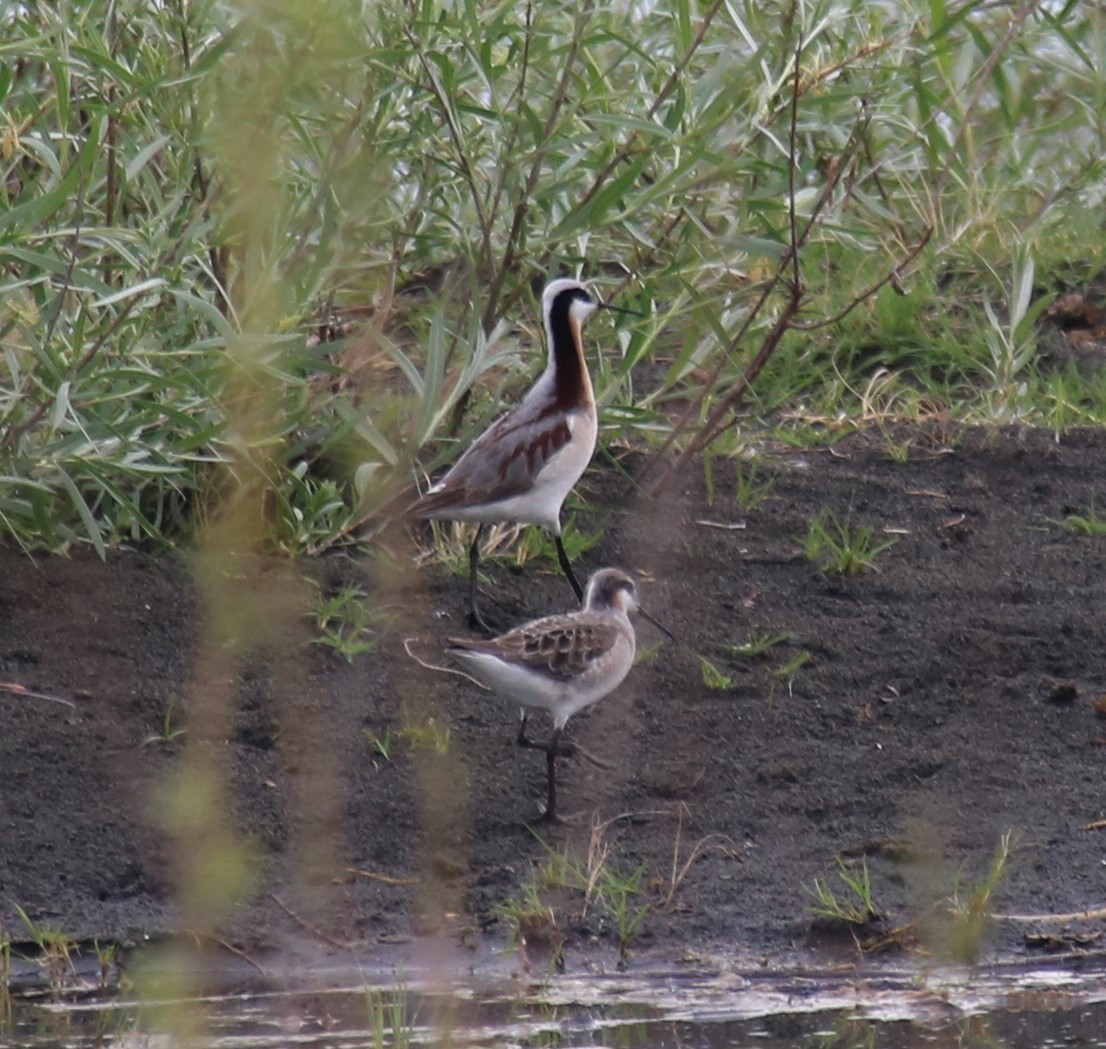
449, 568, 671, 820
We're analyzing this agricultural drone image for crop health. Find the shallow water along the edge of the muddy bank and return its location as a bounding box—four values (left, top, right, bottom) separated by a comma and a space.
0, 959, 1106, 1049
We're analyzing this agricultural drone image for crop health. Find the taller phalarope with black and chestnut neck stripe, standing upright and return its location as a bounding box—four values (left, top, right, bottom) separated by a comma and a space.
407, 279, 633, 633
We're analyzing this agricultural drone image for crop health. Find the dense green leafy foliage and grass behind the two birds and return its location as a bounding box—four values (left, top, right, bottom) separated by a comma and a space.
0, 0, 1106, 554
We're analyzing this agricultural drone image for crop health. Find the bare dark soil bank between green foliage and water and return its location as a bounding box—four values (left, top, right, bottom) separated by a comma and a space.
0, 429, 1106, 964
